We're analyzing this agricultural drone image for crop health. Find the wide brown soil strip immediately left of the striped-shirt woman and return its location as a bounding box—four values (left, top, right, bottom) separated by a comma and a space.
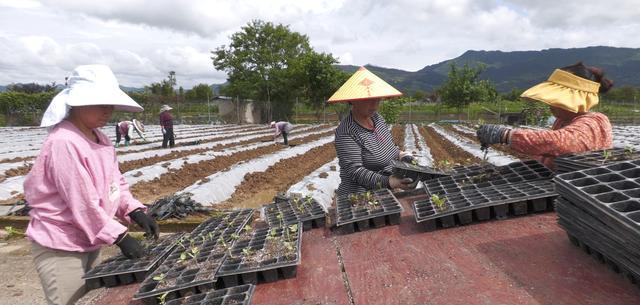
221, 142, 336, 208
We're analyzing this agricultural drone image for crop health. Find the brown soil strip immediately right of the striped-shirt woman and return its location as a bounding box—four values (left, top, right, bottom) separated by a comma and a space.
418, 126, 482, 169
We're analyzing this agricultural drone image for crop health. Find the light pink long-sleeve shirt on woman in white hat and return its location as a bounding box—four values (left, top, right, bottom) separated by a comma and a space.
24, 121, 144, 252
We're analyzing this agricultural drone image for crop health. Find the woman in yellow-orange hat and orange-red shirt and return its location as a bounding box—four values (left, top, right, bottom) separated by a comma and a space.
477, 62, 613, 169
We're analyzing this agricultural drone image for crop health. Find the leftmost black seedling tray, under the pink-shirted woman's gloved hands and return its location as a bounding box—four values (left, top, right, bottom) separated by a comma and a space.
82, 233, 184, 289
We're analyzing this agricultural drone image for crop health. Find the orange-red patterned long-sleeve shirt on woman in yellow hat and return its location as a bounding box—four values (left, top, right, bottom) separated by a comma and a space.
509, 112, 613, 169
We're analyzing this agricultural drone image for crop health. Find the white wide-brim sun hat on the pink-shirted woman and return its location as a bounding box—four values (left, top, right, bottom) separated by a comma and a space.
40, 65, 144, 127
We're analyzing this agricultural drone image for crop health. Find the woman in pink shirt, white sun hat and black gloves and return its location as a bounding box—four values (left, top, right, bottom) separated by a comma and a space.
24, 65, 158, 305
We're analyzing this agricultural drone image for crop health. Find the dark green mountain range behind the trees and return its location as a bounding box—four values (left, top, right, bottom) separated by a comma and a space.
338, 46, 640, 93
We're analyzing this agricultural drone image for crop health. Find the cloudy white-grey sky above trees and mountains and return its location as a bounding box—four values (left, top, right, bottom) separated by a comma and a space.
0, 0, 640, 88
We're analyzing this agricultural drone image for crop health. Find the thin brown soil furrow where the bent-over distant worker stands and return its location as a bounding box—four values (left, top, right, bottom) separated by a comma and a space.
119, 125, 328, 173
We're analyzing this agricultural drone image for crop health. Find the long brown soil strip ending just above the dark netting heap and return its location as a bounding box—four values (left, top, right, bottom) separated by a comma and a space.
131, 130, 334, 204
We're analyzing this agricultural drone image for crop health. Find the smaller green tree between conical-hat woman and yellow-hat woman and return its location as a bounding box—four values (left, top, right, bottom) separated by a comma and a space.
438, 63, 498, 114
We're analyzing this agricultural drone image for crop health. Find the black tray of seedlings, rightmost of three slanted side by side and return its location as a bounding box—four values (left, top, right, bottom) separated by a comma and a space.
217, 224, 302, 287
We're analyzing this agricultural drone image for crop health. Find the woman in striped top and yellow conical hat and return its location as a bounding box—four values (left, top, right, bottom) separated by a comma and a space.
328, 67, 417, 196
